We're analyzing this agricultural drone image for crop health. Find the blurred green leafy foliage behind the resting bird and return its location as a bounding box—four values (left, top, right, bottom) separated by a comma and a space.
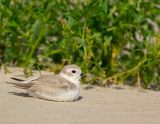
0, 0, 160, 90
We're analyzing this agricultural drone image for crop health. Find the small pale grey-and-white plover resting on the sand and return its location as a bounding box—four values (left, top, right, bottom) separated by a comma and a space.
7, 65, 82, 101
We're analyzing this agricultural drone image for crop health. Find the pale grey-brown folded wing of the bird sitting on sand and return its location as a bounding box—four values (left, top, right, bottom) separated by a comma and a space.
28, 75, 76, 94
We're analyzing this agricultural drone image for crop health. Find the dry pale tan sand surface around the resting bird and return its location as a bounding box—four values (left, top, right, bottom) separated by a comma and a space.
0, 68, 160, 124
